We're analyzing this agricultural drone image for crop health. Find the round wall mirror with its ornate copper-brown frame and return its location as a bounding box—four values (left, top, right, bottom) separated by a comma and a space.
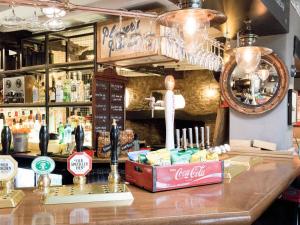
220, 53, 289, 114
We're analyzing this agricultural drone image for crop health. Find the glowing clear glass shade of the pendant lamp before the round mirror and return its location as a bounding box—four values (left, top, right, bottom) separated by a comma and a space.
235, 46, 261, 73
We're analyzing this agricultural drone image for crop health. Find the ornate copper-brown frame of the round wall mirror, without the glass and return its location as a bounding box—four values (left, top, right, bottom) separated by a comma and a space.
220, 53, 289, 115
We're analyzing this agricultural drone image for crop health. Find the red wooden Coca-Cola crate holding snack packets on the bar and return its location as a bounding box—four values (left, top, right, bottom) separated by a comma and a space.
125, 160, 224, 192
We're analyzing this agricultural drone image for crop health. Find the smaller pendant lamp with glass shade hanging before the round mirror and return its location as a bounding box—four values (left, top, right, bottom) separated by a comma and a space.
233, 20, 272, 73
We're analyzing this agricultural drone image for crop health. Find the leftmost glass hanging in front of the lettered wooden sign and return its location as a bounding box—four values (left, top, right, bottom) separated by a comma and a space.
127, 11, 143, 51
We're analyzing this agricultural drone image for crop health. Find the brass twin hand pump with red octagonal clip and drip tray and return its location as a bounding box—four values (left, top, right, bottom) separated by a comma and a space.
44, 122, 133, 205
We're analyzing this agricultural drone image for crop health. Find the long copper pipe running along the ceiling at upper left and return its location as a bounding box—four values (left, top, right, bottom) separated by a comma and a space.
0, 0, 157, 18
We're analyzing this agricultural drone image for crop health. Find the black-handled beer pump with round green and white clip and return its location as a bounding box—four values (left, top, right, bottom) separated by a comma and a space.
31, 118, 55, 195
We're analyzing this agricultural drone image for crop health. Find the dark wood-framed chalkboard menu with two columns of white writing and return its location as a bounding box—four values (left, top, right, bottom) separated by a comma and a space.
93, 69, 127, 146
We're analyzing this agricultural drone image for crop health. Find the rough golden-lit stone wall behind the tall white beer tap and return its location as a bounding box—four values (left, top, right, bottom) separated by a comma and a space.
126, 70, 220, 145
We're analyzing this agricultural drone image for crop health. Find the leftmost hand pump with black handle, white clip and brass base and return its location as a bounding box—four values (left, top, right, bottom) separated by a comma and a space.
0, 125, 25, 208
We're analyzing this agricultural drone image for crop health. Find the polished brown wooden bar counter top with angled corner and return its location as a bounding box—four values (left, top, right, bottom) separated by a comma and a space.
0, 158, 300, 225
